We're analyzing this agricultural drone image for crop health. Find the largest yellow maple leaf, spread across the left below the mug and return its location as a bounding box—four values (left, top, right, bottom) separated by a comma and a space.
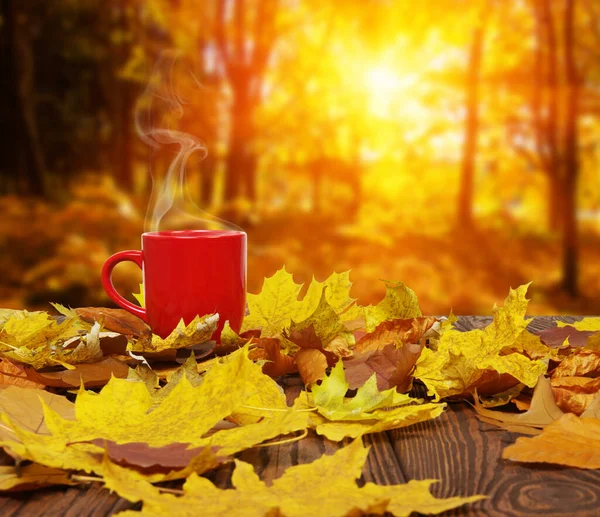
1, 348, 308, 481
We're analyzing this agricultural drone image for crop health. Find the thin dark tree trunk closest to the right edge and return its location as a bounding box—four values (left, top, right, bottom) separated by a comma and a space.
562, 0, 580, 296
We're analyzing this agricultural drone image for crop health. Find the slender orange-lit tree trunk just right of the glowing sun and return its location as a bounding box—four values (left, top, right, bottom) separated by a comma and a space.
458, 10, 485, 228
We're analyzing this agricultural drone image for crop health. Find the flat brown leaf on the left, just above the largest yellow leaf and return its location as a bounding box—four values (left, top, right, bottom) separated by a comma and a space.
25, 357, 129, 388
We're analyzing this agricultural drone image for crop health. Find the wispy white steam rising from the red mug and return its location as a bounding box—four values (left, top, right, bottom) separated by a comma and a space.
135, 51, 240, 232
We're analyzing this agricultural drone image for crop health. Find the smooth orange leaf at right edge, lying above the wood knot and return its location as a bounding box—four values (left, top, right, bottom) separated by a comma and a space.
502, 413, 600, 469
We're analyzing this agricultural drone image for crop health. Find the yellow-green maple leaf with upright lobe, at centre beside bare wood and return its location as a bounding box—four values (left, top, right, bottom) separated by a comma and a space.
295, 361, 446, 441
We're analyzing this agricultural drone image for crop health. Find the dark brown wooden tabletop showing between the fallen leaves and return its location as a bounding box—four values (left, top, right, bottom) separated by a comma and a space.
0, 317, 600, 517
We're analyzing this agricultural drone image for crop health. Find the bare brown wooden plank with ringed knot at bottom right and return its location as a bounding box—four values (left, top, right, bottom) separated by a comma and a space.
388, 403, 600, 517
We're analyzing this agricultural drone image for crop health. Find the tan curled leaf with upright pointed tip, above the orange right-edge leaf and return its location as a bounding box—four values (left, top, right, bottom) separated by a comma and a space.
475, 375, 564, 434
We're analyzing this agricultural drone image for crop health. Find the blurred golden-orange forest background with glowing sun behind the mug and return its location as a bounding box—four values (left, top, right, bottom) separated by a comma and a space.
0, 0, 600, 314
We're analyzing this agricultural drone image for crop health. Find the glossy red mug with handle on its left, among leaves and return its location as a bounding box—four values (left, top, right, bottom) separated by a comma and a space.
102, 230, 246, 339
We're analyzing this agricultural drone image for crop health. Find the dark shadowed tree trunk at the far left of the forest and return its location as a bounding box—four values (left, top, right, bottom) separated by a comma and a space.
2, 0, 47, 196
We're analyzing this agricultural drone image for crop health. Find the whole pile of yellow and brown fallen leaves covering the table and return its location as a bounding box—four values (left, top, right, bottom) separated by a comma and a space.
0, 269, 600, 516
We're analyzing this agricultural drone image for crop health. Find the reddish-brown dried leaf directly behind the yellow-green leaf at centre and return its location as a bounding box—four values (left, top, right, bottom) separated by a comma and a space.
344, 342, 423, 393
